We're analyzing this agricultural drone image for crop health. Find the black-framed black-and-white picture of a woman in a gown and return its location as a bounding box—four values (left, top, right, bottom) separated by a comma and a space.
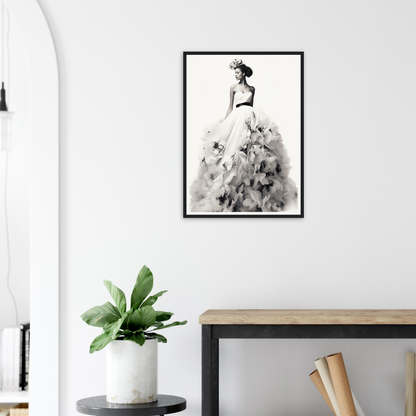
183, 52, 304, 218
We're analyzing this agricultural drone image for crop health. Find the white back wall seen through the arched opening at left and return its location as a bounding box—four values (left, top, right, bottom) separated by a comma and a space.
0, 4, 30, 328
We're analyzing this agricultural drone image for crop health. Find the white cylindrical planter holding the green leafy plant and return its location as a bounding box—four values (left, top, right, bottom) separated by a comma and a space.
106, 339, 158, 404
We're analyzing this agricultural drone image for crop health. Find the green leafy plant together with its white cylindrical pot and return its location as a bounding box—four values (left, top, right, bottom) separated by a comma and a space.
81, 266, 187, 404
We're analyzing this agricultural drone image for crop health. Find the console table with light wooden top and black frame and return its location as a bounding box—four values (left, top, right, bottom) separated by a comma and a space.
199, 309, 416, 416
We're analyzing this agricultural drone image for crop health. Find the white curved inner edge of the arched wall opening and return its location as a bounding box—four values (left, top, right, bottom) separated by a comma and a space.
4, 0, 59, 416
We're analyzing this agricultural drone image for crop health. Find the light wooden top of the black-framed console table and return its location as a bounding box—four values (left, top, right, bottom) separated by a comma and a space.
199, 309, 416, 325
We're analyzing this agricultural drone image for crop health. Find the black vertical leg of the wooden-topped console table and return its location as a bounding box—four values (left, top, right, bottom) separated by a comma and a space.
202, 325, 219, 416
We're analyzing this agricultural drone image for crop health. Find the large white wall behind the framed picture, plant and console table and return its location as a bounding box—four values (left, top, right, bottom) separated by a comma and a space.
36, 0, 416, 416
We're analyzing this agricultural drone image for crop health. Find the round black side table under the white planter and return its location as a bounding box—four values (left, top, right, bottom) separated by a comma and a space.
77, 394, 186, 416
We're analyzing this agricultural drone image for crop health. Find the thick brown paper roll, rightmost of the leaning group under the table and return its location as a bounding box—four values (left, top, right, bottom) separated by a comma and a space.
326, 352, 357, 416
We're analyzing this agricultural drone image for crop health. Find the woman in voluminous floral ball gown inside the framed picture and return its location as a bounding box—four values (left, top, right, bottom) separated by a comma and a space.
191, 59, 297, 212
